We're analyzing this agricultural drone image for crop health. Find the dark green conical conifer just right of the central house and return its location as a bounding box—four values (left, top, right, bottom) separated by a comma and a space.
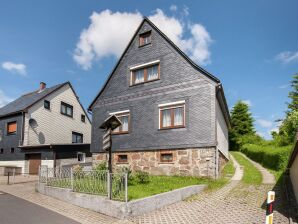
229, 101, 256, 150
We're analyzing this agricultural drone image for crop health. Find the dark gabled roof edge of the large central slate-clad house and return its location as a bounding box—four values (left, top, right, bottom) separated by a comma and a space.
88, 17, 230, 124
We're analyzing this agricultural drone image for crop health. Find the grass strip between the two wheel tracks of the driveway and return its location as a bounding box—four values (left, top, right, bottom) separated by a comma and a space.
231, 152, 262, 184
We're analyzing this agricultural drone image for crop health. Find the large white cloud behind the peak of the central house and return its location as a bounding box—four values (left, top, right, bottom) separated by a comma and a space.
73, 7, 212, 70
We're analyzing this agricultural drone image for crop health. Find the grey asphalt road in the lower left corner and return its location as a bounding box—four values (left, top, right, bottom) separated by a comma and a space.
0, 192, 79, 224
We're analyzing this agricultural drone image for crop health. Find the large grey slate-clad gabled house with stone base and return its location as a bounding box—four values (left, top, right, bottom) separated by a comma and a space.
88, 18, 230, 177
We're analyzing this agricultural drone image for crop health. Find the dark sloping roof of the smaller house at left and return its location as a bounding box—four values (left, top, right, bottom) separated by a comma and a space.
0, 82, 69, 117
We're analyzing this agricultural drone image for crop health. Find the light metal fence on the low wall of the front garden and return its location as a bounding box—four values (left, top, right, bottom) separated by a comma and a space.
39, 166, 128, 202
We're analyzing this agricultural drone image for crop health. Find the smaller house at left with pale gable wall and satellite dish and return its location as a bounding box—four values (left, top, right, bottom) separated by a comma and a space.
0, 82, 92, 173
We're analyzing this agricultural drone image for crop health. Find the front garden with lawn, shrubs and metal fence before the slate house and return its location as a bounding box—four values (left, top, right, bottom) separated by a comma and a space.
40, 158, 235, 201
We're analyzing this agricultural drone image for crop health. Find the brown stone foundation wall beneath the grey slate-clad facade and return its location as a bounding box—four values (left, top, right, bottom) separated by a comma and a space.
93, 147, 216, 178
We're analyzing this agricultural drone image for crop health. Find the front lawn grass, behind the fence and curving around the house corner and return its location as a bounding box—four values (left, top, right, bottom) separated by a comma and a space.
48, 158, 235, 200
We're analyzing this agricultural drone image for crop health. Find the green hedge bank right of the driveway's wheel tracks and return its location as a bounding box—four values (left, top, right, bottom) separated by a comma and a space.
241, 144, 292, 171
